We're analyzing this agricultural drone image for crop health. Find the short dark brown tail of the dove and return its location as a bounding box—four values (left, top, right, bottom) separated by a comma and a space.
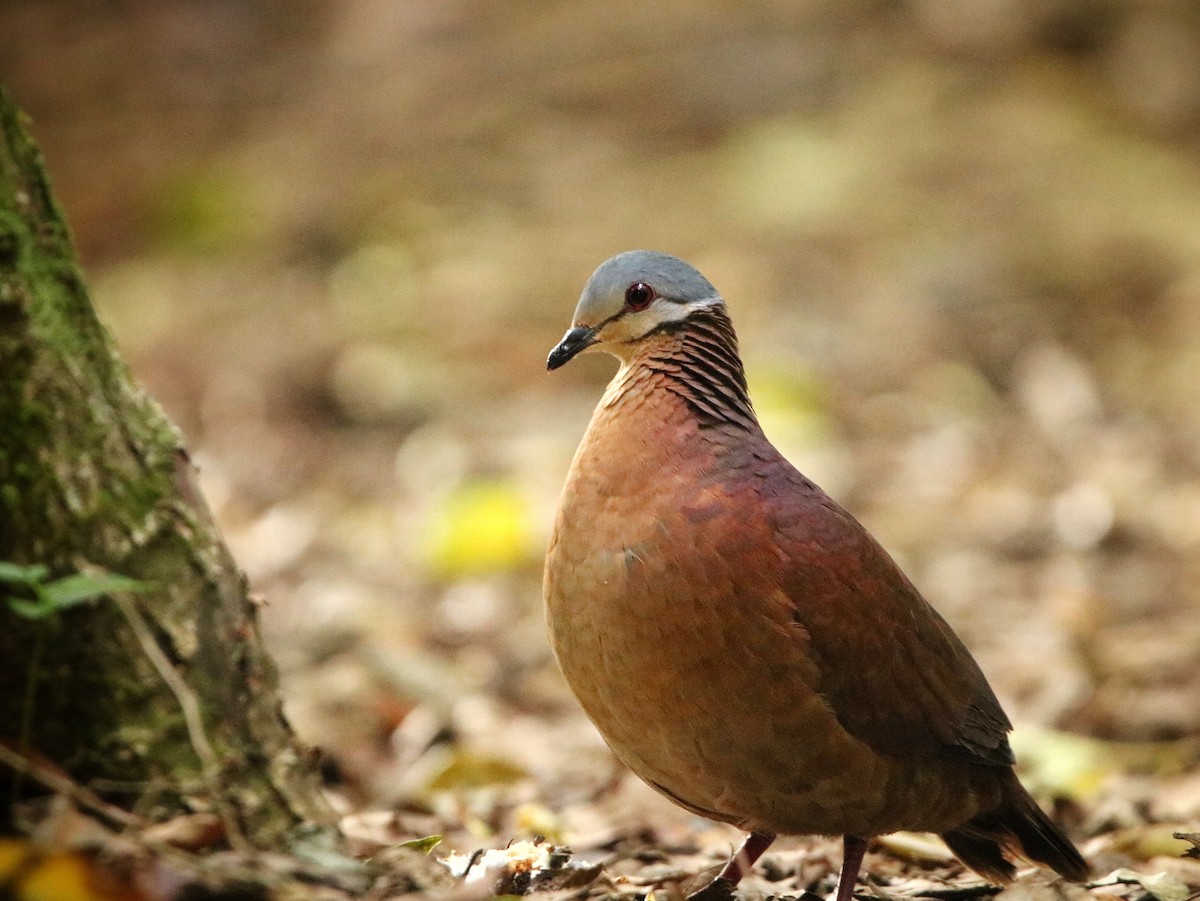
942, 776, 1088, 883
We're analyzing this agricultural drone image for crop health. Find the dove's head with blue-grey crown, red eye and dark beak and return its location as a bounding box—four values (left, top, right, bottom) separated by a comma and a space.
546, 251, 724, 370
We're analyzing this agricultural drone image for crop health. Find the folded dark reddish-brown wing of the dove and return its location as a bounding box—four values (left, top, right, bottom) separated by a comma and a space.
767, 467, 1013, 767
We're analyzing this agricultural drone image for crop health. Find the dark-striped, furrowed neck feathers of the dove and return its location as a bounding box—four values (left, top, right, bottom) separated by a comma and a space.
641, 305, 758, 432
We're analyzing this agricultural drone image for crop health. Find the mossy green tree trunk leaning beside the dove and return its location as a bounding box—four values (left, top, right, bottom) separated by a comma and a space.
0, 88, 328, 847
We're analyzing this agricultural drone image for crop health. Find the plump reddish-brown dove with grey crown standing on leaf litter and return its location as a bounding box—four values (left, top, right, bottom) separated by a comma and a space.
544, 251, 1088, 901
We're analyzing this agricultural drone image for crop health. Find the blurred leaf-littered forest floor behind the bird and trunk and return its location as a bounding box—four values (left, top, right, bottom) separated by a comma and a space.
0, 0, 1200, 901
